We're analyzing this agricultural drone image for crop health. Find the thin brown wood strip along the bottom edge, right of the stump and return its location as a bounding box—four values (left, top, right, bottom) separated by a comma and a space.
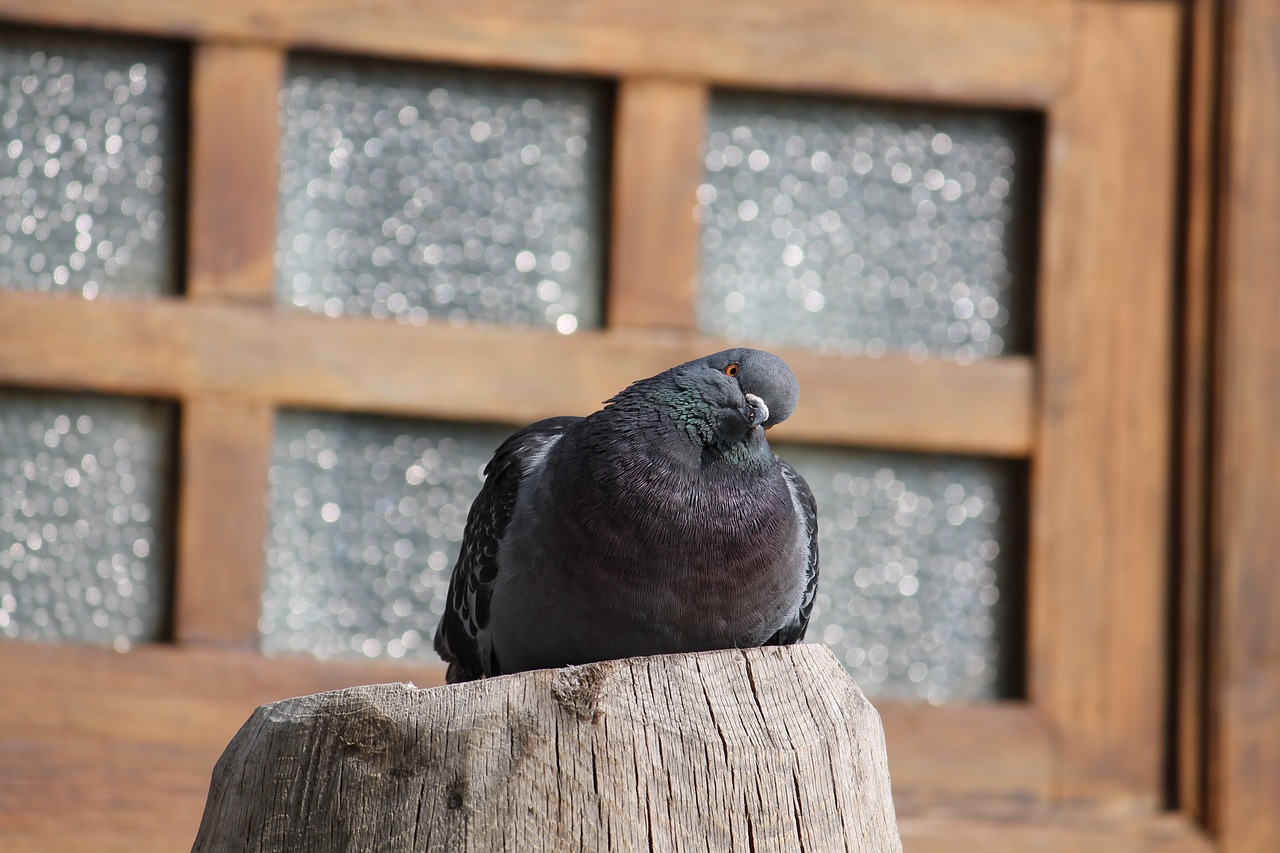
899, 813, 1216, 853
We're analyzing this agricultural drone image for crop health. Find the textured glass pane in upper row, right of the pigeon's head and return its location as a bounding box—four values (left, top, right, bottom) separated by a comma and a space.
698, 95, 1038, 361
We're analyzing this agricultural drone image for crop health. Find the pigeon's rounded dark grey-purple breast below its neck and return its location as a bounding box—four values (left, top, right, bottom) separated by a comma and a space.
483, 440, 808, 667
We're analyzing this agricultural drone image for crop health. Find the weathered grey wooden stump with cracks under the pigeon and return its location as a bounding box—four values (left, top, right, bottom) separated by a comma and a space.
195, 646, 902, 853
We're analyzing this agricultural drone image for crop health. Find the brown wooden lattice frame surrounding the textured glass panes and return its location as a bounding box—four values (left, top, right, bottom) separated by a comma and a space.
0, 0, 1254, 850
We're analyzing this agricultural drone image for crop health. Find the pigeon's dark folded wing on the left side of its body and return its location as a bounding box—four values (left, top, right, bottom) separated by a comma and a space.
435, 418, 581, 684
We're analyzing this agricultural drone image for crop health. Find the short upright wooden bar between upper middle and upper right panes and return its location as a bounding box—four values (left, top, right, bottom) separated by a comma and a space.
608, 78, 708, 332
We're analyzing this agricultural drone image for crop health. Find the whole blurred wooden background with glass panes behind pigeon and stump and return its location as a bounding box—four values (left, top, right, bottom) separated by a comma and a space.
0, 0, 1280, 850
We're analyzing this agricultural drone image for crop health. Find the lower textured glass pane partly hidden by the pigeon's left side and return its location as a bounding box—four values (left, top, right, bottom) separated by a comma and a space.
261, 411, 512, 661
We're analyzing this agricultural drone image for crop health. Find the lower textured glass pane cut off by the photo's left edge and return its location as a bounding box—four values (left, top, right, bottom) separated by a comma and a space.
0, 392, 173, 651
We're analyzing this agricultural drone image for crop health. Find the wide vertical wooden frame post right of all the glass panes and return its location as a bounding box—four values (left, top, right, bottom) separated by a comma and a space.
1029, 0, 1180, 811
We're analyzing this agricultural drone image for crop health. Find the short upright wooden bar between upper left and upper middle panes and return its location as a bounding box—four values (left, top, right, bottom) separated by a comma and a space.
187, 42, 284, 304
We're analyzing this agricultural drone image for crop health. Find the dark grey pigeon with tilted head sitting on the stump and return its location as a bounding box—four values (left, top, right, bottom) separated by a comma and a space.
435, 348, 818, 684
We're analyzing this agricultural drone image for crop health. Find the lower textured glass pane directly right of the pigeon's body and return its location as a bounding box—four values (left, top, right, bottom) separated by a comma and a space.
780, 446, 1025, 703
